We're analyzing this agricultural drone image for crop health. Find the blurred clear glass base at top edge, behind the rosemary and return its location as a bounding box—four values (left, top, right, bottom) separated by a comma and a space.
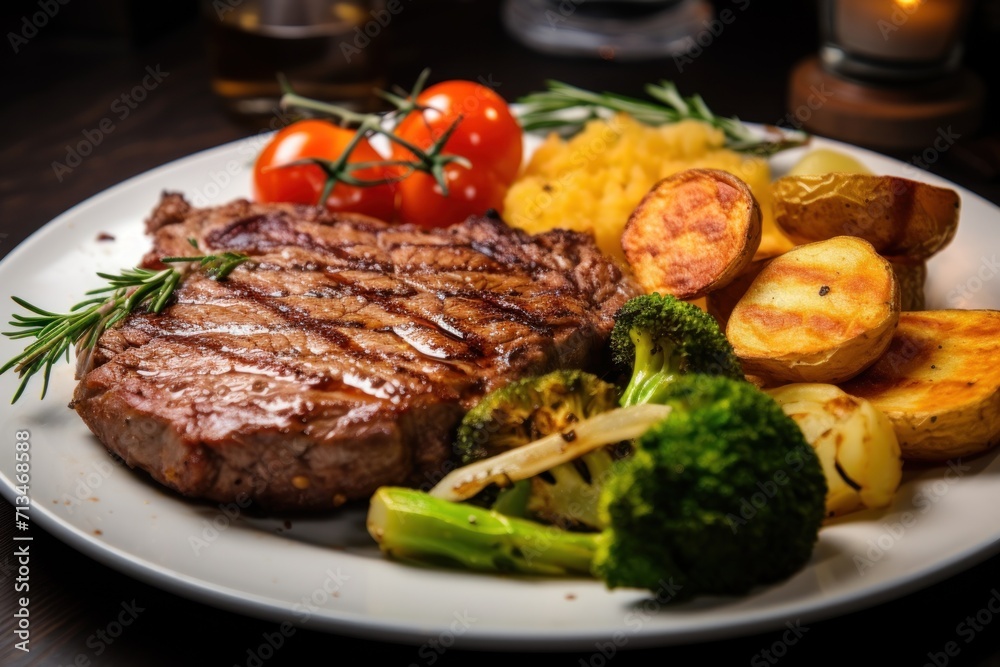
503, 0, 713, 61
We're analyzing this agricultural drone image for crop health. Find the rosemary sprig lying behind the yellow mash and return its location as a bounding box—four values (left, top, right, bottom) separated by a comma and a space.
518, 81, 808, 157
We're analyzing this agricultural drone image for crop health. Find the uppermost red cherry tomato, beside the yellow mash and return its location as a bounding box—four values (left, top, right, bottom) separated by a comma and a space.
393, 80, 523, 185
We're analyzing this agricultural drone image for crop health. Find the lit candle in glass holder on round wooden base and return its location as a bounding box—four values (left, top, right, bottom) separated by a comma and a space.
789, 0, 986, 150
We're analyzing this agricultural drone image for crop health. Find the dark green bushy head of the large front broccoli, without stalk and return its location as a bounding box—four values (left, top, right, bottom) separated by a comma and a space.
594, 375, 827, 598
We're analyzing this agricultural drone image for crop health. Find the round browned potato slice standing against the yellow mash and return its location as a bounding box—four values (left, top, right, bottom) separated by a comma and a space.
622, 169, 761, 300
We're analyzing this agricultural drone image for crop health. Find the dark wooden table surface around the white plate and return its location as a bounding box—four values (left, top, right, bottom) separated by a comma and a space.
0, 1, 1000, 666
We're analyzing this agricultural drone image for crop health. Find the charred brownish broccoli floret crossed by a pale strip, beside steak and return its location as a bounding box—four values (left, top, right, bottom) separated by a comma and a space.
455, 370, 628, 529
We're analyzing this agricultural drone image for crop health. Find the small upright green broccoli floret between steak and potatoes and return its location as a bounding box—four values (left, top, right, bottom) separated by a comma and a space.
611, 293, 745, 406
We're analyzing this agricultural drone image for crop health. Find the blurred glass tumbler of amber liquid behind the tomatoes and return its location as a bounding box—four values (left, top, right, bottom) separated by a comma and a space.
202, 0, 392, 125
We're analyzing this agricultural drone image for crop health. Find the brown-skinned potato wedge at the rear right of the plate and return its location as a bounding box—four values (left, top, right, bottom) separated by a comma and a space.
771, 172, 960, 259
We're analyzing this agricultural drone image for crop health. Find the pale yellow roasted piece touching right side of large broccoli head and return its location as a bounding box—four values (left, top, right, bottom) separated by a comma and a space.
766, 383, 903, 517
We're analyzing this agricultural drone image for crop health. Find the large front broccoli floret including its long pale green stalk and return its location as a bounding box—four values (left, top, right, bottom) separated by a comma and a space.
368, 374, 827, 600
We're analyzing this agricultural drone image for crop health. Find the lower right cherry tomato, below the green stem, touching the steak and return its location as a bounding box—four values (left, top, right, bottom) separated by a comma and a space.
398, 164, 507, 227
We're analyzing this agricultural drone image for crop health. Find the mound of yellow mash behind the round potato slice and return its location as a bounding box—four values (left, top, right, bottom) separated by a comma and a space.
504, 115, 793, 266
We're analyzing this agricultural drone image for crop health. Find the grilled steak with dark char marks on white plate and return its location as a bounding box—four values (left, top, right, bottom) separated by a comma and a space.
72, 193, 636, 510
